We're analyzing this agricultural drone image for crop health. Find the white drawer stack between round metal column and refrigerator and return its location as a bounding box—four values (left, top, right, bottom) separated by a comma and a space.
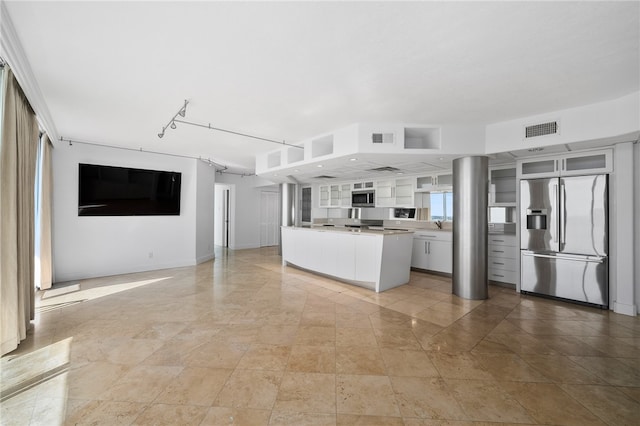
488, 234, 519, 284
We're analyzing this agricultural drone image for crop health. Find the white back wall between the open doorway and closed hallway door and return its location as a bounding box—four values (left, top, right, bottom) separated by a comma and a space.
216, 173, 279, 250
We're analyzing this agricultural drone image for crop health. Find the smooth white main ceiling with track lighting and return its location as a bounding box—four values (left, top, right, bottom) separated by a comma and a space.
5, 1, 640, 175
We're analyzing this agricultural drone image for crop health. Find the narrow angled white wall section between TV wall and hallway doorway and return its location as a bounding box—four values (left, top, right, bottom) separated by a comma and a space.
196, 161, 216, 263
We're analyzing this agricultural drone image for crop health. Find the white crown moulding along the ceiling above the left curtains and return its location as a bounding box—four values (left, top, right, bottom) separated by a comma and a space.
0, 1, 59, 142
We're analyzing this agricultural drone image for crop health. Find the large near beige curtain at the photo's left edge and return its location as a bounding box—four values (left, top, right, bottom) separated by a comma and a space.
0, 67, 38, 355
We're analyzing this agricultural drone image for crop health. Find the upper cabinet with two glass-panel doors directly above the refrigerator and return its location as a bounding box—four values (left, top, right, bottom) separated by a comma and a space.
518, 149, 613, 179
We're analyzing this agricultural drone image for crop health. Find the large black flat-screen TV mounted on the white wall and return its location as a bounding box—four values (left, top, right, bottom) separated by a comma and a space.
78, 164, 181, 216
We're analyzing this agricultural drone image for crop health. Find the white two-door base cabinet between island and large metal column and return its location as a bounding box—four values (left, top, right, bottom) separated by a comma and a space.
411, 231, 453, 274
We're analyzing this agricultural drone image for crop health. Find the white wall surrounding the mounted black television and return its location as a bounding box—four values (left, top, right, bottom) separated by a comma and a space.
52, 144, 198, 282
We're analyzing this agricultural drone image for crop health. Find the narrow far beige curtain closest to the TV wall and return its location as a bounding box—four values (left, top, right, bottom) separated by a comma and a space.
36, 135, 53, 290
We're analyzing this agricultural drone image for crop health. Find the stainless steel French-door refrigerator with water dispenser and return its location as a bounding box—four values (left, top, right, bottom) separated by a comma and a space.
520, 175, 609, 308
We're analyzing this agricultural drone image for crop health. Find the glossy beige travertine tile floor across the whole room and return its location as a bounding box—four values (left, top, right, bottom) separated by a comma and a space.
1, 248, 640, 426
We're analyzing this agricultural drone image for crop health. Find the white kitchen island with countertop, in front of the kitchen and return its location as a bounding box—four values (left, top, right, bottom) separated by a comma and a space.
282, 226, 413, 293
